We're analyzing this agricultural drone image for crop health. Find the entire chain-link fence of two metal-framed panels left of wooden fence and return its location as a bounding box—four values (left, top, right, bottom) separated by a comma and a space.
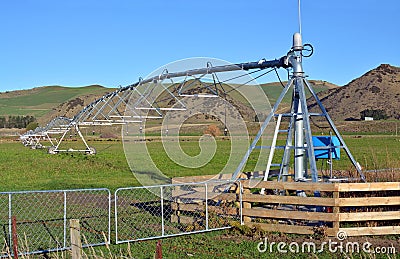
0, 181, 242, 258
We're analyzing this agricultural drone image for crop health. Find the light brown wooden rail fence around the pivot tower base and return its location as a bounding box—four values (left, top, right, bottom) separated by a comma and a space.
174, 176, 400, 236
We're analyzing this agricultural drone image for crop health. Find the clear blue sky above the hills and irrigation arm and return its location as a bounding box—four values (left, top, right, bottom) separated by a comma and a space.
0, 0, 400, 91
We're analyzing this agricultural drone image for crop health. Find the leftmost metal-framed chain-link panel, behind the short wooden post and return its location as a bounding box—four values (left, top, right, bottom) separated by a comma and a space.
0, 189, 111, 257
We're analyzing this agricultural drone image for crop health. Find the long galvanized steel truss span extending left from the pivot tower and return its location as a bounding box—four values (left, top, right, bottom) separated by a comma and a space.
21, 57, 288, 154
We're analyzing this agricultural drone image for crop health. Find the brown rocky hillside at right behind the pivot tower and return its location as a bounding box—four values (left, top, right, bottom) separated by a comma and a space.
309, 64, 400, 120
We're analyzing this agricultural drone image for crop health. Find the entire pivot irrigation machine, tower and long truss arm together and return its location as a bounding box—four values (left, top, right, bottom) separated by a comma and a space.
21, 1, 365, 185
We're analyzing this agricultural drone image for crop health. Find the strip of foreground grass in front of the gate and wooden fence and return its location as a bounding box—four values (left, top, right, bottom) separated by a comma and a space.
88, 230, 396, 259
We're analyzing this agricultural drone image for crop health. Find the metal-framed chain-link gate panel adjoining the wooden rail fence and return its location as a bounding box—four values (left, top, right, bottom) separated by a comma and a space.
115, 181, 241, 244
